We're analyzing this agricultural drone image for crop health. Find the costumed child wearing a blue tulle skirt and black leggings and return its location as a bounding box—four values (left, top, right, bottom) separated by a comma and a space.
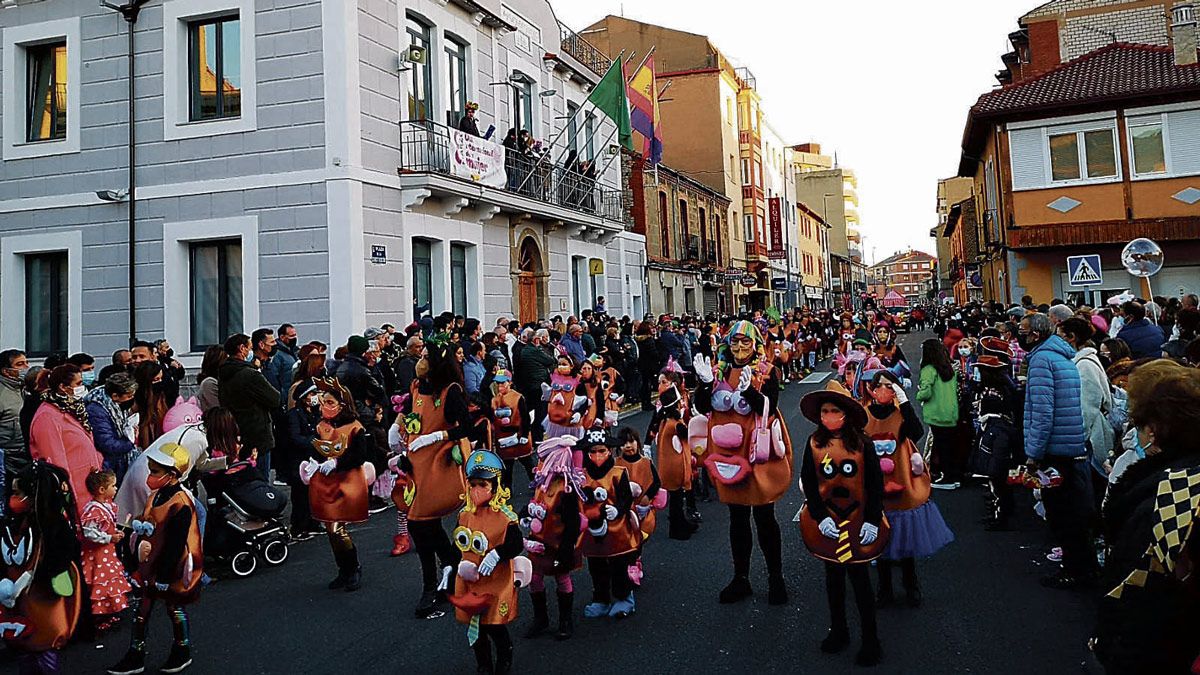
866, 370, 954, 607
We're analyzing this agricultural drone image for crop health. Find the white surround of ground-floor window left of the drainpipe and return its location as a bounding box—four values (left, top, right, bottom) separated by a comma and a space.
0, 229, 83, 353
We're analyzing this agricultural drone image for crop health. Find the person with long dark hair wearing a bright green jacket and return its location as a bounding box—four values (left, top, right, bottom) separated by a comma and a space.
917, 338, 967, 490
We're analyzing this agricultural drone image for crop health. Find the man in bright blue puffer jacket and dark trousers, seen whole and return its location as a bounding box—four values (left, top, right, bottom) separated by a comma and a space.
1018, 313, 1097, 589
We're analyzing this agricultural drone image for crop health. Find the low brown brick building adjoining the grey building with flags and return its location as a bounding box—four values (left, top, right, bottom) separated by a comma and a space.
630, 159, 730, 316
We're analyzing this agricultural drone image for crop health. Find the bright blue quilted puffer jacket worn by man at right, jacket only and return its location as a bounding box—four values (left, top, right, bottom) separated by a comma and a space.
1025, 335, 1087, 460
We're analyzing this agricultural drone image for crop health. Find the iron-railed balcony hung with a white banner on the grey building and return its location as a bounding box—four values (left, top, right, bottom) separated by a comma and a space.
398, 120, 625, 225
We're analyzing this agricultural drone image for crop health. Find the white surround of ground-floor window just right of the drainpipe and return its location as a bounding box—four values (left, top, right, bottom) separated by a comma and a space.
162, 216, 259, 357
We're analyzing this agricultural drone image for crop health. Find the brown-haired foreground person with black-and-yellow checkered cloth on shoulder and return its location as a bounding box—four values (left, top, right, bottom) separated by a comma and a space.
1091, 359, 1200, 673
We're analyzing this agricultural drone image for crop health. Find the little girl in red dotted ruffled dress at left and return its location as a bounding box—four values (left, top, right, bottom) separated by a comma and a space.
79, 470, 130, 631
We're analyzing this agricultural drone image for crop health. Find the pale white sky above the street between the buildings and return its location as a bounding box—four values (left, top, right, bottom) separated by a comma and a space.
551, 0, 1040, 261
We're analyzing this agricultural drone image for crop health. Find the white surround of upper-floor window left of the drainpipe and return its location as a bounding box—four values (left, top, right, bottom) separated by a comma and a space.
0, 17, 83, 159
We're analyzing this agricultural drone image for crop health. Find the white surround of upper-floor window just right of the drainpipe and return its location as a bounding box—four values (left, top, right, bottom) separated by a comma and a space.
162, 0, 258, 141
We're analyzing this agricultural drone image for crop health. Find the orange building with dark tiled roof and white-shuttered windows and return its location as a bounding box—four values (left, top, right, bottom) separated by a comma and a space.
959, 2, 1200, 306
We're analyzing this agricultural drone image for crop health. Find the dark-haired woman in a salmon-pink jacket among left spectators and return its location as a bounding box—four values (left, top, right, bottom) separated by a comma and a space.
29, 364, 103, 515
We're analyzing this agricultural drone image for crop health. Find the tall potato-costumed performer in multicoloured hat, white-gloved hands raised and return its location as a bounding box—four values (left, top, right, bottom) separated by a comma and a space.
689, 321, 792, 605
